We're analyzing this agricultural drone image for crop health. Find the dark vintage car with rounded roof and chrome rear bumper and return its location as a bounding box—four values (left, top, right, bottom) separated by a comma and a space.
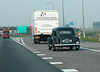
48, 27, 80, 51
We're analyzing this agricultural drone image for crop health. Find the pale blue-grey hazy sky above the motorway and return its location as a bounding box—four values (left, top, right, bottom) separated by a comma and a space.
0, 0, 100, 27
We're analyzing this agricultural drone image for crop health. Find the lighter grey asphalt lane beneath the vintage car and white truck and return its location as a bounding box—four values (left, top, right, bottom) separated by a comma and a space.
23, 37, 100, 72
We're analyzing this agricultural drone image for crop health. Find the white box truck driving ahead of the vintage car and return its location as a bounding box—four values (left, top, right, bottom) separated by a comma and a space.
33, 10, 59, 44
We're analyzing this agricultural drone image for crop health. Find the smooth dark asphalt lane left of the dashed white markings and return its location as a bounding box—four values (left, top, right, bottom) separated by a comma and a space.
0, 37, 62, 72
